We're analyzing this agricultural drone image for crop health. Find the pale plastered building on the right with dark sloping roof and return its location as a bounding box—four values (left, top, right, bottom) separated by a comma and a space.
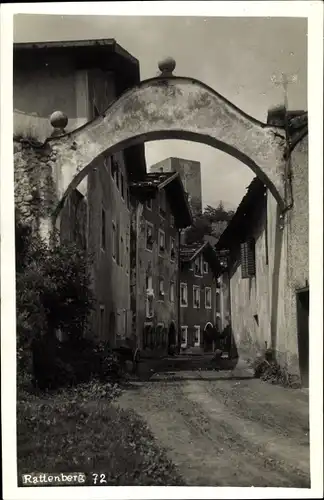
216, 113, 309, 386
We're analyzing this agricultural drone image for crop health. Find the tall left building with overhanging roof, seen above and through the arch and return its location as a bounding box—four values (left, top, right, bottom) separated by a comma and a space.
14, 40, 146, 345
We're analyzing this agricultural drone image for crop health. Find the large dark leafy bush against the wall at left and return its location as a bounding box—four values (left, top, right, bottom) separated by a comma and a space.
16, 212, 94, 387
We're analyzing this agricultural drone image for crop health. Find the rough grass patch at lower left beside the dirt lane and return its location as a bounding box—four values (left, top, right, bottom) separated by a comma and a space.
17, 382, 184, 486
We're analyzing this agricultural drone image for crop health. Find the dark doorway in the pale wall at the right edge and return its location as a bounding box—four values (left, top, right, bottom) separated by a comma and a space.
296, 288, 309, 387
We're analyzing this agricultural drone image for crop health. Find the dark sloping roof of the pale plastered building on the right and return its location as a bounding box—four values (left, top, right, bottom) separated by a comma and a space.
215, 177, 266, 251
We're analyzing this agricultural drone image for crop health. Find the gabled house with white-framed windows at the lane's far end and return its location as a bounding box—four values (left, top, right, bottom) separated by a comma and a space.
180, 242, 220, 352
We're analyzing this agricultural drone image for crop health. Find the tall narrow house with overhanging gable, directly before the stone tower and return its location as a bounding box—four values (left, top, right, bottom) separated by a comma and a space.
131, 172, 192, 356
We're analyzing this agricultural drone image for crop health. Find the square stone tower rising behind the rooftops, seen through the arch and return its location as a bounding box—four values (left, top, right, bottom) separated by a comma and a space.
150, 157, 202, 216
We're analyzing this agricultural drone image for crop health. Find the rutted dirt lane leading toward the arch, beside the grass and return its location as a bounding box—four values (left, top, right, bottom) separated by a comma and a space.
118, 372, 310, 488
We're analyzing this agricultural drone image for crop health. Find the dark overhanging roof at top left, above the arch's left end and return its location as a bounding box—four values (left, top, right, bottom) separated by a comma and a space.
14, 38, 140, 92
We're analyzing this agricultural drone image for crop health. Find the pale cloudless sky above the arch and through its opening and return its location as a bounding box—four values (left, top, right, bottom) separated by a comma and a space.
14, 14, 307, 208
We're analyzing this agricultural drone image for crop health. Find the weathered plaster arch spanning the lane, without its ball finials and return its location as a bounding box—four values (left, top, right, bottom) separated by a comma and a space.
49, 77, 286, 212
